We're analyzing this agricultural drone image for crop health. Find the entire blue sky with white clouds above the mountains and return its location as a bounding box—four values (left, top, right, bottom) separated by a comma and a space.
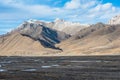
0, 0, 120, 34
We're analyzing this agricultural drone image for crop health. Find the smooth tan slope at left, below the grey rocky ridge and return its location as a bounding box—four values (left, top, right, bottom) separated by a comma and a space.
0, 33, 57, 56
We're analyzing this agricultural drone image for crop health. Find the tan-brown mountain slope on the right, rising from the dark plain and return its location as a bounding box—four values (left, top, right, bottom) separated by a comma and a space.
56, 23, 120, 55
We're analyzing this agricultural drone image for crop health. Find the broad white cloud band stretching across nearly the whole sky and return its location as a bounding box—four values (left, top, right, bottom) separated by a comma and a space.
0, 0, 120, 23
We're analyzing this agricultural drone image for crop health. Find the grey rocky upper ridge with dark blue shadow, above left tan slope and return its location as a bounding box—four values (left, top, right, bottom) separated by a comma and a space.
13, 22, 70, 48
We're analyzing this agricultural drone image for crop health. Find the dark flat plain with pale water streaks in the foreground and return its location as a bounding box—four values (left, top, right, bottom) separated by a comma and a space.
0, 56, 120, 80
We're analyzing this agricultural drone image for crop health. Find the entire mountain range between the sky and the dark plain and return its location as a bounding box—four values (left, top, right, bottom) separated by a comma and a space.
0, 16, 120, 56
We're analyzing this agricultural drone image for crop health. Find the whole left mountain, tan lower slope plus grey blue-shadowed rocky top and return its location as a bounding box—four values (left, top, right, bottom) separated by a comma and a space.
0, 22, 70, 55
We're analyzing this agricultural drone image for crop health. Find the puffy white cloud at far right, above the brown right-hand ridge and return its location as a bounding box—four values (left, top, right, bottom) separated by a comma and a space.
88, 3, 120, 19
